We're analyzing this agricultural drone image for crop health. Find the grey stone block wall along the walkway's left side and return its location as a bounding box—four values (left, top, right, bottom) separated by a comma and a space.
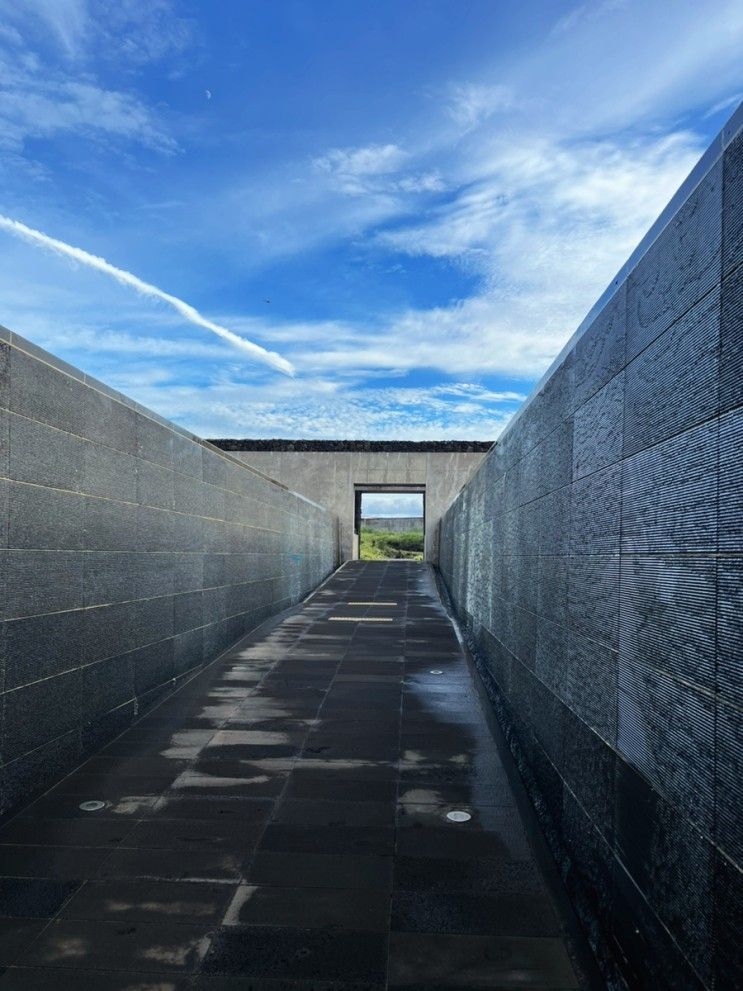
0, 328, 335, 812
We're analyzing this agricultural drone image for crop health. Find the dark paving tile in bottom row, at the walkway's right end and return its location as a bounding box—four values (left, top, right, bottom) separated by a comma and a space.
389, 933, 578, 991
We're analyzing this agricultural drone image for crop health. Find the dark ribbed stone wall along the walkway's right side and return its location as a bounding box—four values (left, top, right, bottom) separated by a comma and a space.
441, 112, 743, 991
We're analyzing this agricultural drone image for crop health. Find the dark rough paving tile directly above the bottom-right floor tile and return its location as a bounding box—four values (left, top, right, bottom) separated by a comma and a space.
391, 891, 560, 936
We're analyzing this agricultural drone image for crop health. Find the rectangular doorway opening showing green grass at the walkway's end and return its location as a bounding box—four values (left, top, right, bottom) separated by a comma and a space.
354, 485, 426, 561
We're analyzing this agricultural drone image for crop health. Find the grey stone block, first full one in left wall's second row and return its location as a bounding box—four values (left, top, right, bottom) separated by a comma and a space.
9, 415, 85, 492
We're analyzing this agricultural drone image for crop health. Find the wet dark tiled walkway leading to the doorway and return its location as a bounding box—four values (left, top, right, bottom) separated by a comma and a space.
0, 562, 596, 991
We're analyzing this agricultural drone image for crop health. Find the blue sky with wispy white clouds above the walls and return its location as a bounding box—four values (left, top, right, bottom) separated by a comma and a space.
0, 0, 743, 439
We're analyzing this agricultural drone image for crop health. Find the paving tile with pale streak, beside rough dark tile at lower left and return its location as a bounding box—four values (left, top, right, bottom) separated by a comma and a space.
60, 878, 236, 923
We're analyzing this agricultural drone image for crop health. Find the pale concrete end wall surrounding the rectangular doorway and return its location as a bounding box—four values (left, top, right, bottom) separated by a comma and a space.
215, 441, 484, 561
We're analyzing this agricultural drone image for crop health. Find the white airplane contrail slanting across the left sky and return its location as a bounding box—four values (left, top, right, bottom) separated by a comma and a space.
0, 214, 294, 375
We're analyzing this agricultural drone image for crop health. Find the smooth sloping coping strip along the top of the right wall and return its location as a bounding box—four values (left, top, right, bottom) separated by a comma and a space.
495, 95, 743, 452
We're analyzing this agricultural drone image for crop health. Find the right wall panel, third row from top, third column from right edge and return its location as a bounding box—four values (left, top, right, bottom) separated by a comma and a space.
570, 465, 622, 554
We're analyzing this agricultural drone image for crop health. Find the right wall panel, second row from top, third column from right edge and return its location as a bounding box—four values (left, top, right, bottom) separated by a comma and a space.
573, 375, 624, 479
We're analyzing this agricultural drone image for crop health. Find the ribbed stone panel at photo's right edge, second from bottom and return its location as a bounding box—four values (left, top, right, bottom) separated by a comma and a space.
715, 699, 743, 864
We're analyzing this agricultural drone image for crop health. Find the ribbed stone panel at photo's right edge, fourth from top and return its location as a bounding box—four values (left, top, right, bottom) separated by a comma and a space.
717, 557, 743, 705
